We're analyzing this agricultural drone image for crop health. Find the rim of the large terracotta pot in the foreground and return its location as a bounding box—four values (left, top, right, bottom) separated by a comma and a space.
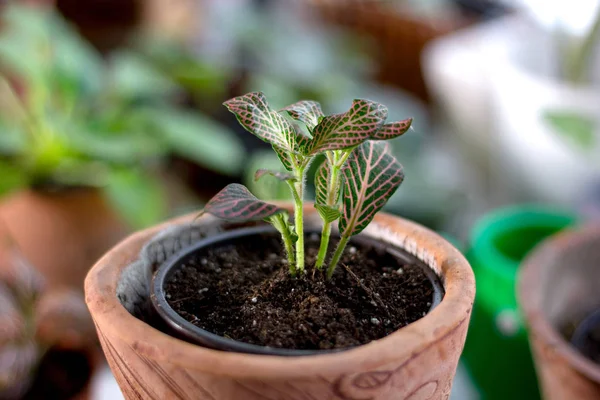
85, 203, 475, 378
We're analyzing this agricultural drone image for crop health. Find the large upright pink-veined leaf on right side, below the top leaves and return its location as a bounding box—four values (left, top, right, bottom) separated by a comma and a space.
339, 141, 404, 237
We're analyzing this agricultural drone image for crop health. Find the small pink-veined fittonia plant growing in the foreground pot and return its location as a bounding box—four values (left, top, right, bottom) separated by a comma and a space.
203, 92, 412, 278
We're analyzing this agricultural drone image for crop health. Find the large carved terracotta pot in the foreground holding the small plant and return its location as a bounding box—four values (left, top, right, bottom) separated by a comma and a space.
85, 205, 475, 400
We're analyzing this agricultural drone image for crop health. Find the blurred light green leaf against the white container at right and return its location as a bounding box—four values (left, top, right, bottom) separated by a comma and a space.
544, 110, 596, 150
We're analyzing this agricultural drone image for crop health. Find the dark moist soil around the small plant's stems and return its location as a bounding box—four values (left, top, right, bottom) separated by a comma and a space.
165, 235, 433, 350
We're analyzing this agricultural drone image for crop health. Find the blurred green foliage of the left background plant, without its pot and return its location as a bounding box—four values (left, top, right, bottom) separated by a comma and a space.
0, 5, 244, 227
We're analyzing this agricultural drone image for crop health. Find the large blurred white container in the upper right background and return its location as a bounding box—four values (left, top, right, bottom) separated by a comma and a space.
424, 15, 600, 204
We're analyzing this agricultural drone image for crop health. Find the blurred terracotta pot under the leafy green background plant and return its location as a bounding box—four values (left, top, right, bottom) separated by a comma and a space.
0, 189, 127, 288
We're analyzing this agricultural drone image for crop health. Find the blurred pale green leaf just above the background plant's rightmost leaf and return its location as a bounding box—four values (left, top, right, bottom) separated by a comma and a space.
111, 52, 179, 98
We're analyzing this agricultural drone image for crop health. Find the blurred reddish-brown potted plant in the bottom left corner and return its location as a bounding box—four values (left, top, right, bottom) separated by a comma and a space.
0, 236, 100, 400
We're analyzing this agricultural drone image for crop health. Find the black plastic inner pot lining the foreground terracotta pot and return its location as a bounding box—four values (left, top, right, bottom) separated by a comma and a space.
150, 225, 444, 356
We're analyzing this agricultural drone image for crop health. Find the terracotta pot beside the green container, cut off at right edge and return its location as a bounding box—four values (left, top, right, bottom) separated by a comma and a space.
518, 227, 600, 400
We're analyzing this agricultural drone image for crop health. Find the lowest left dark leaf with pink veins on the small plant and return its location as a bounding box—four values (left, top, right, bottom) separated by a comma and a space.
202, 183, 287, 222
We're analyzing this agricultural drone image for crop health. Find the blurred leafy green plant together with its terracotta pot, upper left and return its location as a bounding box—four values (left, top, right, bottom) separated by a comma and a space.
0, 5, 243, 287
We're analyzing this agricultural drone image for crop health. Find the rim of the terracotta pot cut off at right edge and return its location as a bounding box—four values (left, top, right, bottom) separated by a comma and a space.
517, 226, 600, 383
